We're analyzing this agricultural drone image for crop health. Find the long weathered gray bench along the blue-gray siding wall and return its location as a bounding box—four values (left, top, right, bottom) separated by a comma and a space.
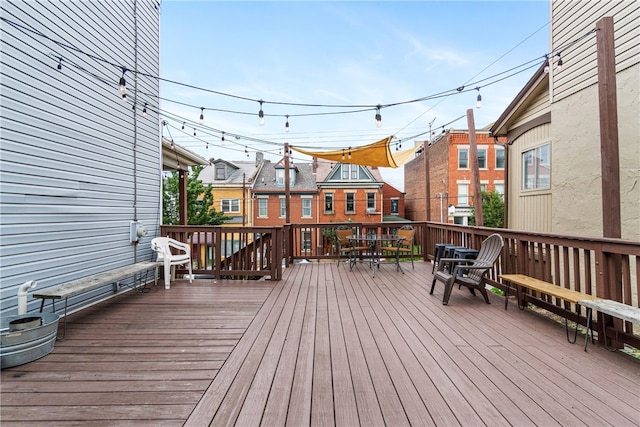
33, 261, 162, 339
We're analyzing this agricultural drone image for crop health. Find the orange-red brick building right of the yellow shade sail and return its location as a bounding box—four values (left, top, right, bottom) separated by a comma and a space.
404, 129, 505, 224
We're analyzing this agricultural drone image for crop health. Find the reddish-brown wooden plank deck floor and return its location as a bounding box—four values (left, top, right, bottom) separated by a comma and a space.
0, 262, 640, 427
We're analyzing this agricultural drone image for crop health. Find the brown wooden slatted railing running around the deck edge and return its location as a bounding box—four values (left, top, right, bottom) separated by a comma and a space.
161, 222, 640, 348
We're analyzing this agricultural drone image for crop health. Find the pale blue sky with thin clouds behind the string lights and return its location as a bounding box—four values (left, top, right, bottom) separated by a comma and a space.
160, 0, 550, 190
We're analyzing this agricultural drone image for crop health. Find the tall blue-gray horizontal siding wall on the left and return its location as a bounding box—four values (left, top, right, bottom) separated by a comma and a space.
0, 0, 161, 315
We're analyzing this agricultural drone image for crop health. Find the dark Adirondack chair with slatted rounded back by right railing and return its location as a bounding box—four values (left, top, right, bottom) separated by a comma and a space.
429, 234, 504, 305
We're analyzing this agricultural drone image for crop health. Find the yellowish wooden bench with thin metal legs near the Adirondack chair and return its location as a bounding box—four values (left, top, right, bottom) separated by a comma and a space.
500, 274, 602, 351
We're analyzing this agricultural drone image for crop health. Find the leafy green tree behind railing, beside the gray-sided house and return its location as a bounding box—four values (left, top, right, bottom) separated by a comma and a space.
162, 166, 230, 225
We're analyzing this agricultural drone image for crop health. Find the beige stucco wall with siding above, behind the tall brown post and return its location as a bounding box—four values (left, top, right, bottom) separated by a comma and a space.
550, 0, 640, 241
